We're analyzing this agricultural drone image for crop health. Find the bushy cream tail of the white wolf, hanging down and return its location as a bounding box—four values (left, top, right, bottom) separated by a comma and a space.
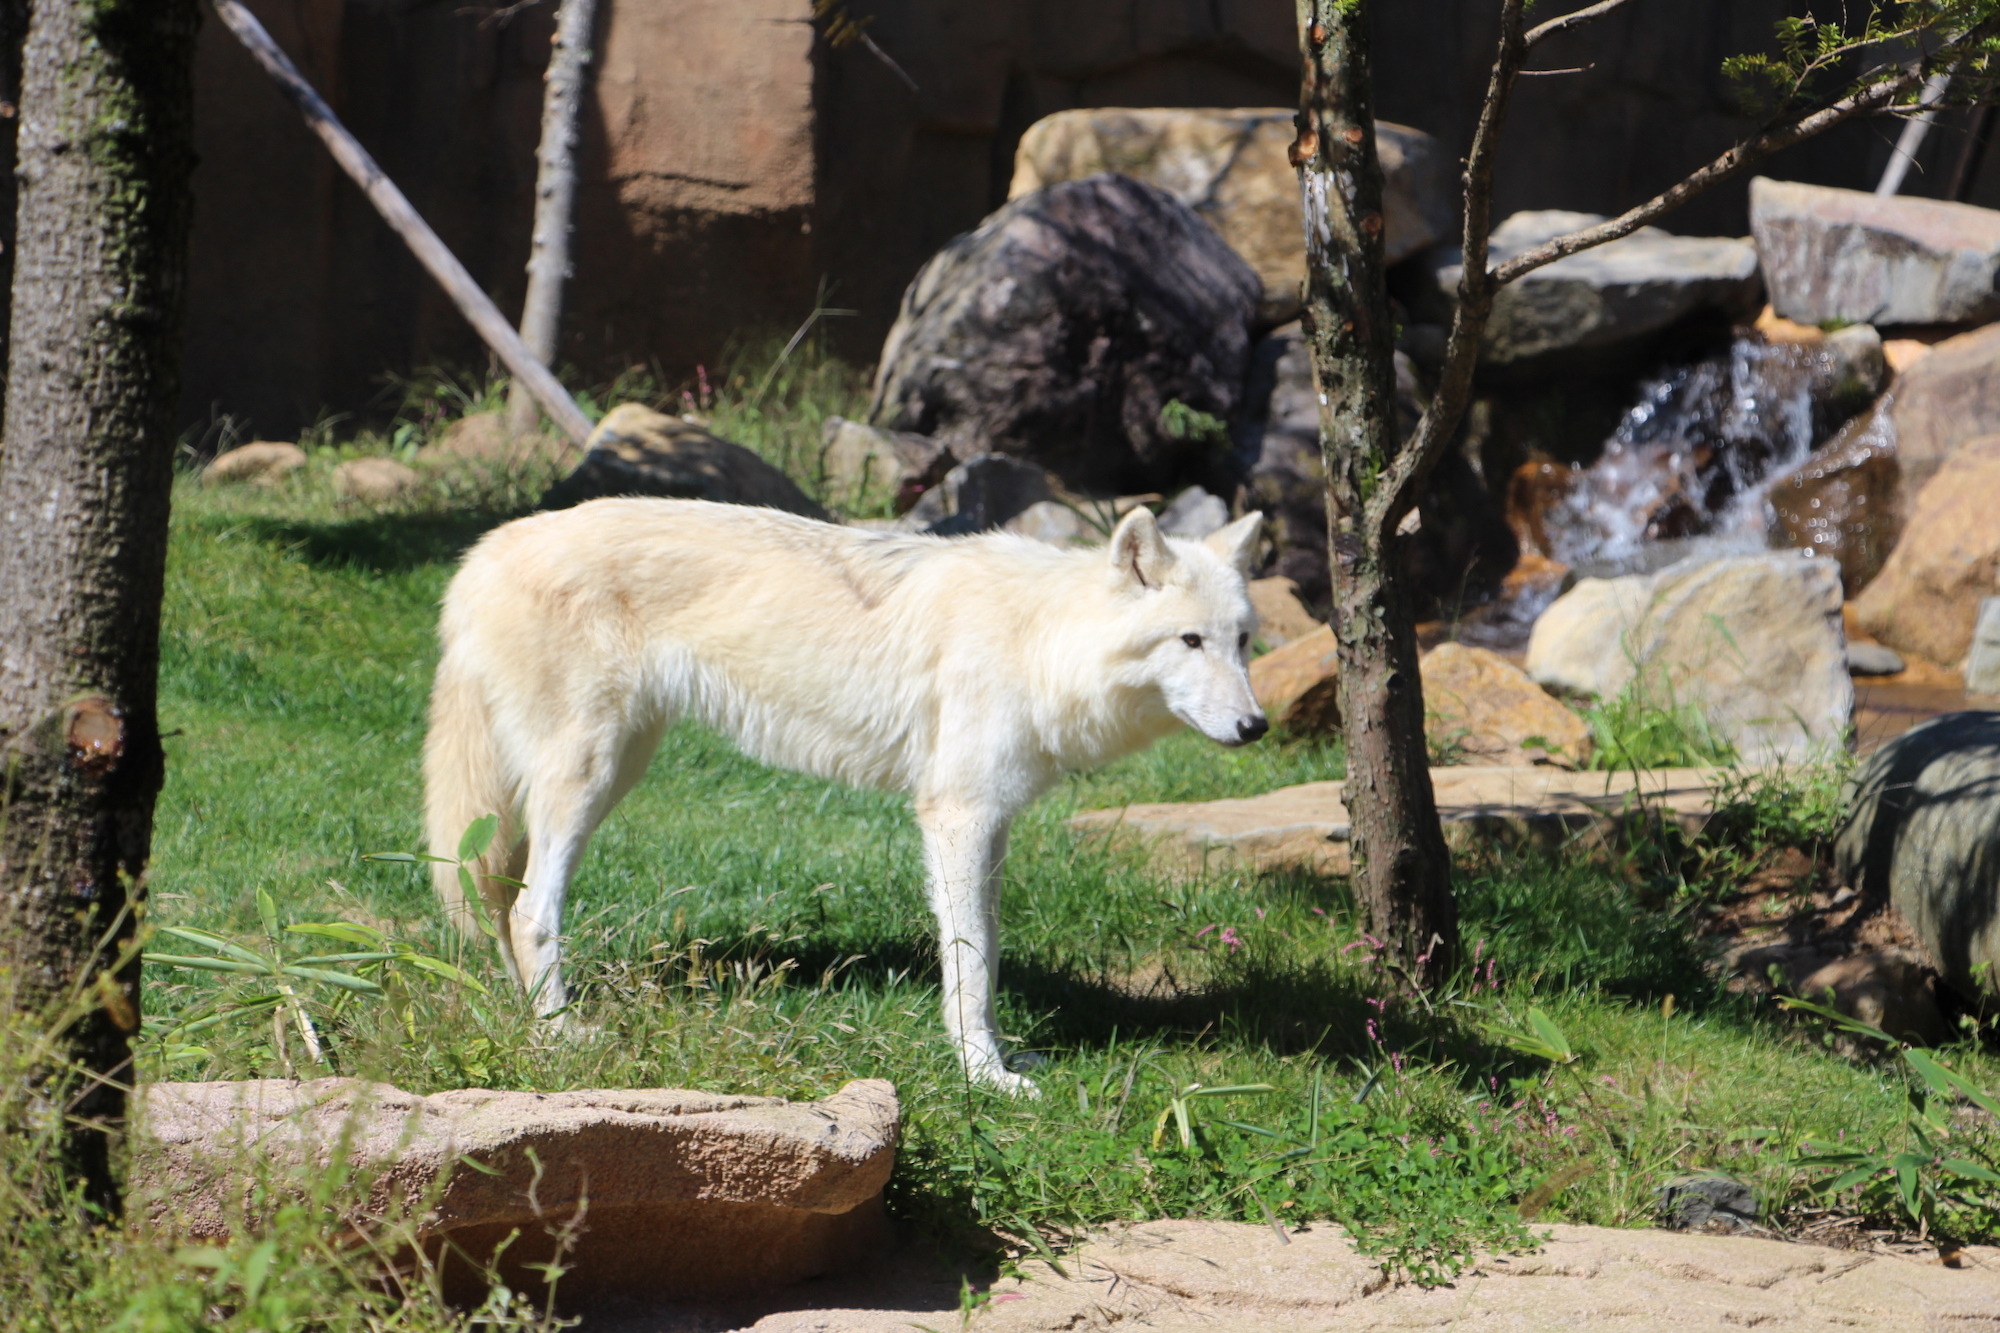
424, 642, 520, 935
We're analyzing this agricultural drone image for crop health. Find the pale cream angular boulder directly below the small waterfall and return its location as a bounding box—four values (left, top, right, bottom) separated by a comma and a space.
1526, 552, 1854, 763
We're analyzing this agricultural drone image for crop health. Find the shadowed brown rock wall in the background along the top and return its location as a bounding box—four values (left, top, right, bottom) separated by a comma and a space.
184, 0, 2000, 434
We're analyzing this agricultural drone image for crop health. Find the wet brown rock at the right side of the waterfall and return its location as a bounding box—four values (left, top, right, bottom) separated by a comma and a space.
1766, 404, 1902, 596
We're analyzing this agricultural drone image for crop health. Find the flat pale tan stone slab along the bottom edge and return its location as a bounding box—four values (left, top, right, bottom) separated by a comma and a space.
628, 1221, 2000, 1333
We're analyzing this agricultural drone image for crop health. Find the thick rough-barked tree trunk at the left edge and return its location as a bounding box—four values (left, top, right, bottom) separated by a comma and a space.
0, 0, 198, 1211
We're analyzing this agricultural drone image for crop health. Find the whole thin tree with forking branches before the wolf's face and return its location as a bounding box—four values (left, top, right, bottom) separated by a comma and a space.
1292, 0, 2000, 981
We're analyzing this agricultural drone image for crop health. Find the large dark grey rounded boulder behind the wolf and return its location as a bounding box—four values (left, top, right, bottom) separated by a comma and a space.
868, 176, 1262, 494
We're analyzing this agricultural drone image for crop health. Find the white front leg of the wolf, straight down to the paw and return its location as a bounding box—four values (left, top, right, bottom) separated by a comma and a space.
916, 801, 1036, 1097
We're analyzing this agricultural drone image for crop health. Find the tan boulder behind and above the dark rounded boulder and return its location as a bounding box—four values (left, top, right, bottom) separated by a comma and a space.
1008, 106, 1456, 324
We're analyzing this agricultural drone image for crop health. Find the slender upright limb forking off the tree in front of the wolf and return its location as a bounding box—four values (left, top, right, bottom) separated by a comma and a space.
1368, 0, 1528, 536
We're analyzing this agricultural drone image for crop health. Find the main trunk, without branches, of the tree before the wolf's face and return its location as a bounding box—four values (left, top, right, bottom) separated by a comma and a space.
1292, 0, 1458, 983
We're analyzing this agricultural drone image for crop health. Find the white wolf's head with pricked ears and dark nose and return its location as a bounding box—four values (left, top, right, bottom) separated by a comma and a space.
1106, 508, 1270, 745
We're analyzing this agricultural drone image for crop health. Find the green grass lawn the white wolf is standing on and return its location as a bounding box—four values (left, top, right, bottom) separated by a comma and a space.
0, 370, 2000, 1329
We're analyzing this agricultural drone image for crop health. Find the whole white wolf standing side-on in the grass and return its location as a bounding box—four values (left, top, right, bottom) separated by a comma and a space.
424, 498, 1266, 1091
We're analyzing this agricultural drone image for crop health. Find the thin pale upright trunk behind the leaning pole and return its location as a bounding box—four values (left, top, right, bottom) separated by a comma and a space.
506, 0, 598, 436
